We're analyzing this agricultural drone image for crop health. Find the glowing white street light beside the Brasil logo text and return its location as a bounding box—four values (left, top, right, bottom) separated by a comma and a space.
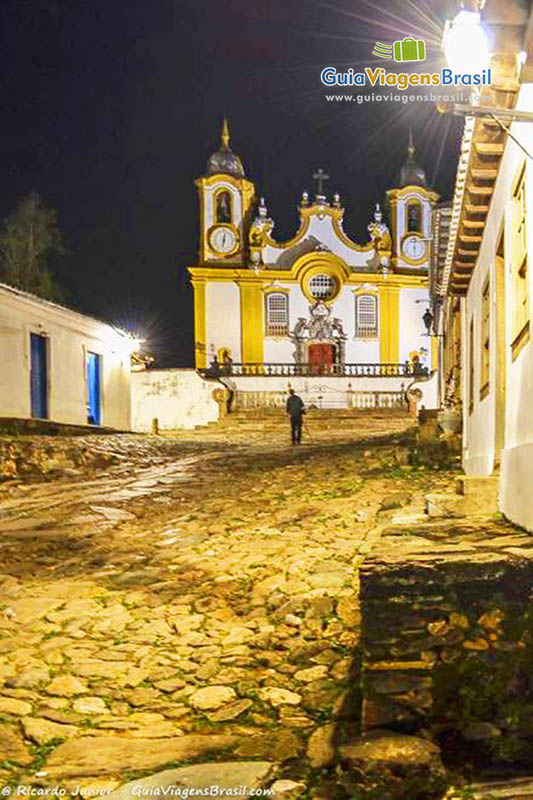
442, 9, 490, 74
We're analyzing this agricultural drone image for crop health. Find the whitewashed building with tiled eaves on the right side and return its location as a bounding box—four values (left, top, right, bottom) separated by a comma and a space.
434, 7, 533, 531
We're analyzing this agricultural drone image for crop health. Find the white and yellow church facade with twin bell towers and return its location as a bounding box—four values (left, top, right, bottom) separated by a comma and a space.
189, 122, 438, 376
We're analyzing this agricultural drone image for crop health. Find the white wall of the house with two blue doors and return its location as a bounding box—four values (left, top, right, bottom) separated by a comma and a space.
0, 285, 131, 430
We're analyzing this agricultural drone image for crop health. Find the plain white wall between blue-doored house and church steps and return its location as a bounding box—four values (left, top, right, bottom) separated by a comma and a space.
131, 369, 223, 432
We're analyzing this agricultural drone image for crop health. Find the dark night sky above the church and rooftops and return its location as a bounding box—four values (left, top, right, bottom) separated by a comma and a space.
0, 0, 462, 366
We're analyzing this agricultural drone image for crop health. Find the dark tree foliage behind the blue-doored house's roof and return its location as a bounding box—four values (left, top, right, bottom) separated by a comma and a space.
0, 192, 65, 300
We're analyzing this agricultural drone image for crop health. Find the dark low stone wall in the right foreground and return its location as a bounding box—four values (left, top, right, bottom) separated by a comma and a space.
361, 520, 533, 766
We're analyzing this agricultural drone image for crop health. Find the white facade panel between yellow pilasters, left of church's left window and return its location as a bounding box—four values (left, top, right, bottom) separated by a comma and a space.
205, 281, 241, 364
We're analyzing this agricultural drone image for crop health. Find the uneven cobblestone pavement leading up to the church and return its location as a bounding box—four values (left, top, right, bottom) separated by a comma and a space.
0, 414, 458, 798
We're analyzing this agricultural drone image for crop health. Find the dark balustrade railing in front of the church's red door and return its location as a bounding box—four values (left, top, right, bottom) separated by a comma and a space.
198, 362, 429, 378
